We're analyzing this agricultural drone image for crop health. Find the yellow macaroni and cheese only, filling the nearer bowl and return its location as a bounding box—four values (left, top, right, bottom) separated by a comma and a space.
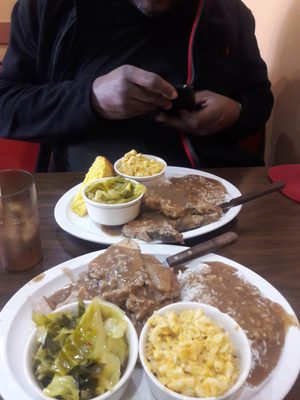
146, 309, 240, 397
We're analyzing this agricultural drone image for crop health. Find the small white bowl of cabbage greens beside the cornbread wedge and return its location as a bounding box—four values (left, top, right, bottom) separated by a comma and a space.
82, 176, 146, 226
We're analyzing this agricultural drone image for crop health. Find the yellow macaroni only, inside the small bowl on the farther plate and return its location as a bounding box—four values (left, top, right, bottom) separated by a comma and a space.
118, 150, 164, 176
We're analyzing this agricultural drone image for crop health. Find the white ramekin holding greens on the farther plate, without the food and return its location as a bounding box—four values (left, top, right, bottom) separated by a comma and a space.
82, 177, 144, 226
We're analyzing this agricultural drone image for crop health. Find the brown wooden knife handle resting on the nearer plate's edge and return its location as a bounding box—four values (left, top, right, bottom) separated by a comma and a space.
166, 232, 238, 267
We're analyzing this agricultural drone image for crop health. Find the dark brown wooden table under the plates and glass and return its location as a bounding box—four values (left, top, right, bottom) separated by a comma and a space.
0, 167, 300, 400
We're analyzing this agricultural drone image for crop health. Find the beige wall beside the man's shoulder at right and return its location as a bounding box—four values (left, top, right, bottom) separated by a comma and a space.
244, 0, 300, 164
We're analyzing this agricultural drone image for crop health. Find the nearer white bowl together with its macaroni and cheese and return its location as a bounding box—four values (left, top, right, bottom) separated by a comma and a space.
139, 302, 251, 400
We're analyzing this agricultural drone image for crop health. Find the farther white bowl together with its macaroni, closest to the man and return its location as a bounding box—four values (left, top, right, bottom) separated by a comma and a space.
114, 150, 167, 184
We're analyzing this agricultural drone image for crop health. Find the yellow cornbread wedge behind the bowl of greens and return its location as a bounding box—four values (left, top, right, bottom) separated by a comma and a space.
71, 156, 115, 217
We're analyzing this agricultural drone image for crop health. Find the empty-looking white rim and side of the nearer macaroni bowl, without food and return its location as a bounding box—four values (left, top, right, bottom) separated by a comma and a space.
139, 302, 251, 400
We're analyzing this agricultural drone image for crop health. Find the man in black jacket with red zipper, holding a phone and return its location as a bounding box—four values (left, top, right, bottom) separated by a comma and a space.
0, 0, 273, 170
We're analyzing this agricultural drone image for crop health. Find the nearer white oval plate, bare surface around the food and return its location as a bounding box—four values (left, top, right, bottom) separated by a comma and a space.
0, 244, 300, 400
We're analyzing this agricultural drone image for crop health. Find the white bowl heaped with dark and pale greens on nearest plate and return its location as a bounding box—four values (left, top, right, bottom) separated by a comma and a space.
24, 298, 138, 400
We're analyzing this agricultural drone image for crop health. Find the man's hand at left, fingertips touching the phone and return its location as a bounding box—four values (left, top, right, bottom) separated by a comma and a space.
92, 65, 177, 119
